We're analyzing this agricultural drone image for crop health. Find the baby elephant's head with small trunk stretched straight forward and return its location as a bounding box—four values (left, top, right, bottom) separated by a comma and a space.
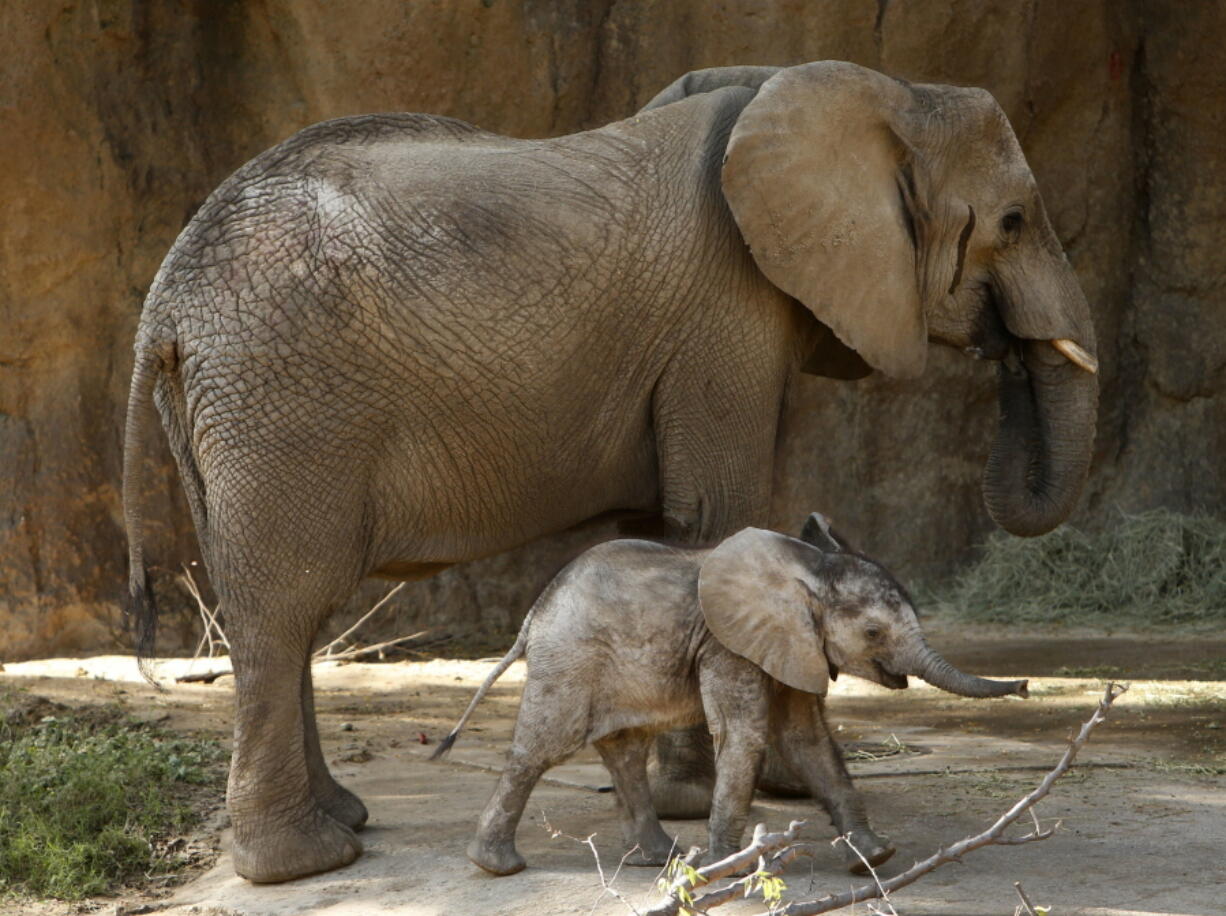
699, 515, 1027, 697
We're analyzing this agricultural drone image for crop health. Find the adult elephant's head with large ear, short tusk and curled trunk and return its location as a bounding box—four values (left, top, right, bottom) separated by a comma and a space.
651, 61, 1097, 535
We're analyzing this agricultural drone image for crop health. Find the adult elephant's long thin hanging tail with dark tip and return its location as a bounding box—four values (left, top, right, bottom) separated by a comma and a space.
124, 348, 166, 685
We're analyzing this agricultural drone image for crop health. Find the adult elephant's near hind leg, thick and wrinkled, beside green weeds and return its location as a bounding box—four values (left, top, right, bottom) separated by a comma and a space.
210, 488, 363, 883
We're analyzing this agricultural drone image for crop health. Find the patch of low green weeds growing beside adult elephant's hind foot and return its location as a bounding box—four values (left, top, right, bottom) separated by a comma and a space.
0, 697, 223, 900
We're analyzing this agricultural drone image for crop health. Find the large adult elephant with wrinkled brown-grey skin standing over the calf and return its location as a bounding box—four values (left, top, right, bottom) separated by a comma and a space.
124, 63, 1096, 882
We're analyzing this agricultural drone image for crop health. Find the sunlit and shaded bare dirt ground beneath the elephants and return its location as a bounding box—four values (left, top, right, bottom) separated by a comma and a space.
0, 628, 1226, 916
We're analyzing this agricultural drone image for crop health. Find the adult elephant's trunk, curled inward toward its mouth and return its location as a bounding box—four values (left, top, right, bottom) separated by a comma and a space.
983, 251, 1098, 537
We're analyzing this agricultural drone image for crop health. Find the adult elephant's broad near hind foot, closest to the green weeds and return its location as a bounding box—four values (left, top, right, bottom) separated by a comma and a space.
233, 807, 362, 884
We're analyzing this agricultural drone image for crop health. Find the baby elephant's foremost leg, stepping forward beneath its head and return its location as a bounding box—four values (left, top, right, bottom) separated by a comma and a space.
772, 685, 894, 874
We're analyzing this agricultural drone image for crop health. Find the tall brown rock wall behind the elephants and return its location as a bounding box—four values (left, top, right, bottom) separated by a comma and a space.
0, 0, 1226, 658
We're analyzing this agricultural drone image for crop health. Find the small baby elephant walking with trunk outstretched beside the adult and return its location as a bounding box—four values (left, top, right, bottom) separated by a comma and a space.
434, 514, 1026, 874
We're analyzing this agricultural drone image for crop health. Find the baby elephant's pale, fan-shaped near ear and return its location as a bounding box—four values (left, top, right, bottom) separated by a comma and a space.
698, 529, 830, 695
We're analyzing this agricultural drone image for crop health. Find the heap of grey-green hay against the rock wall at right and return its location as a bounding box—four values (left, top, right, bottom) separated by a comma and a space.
929, 509, 1226, 628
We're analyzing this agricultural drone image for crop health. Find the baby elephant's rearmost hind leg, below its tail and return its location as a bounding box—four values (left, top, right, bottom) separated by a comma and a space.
468, 681, 587, 876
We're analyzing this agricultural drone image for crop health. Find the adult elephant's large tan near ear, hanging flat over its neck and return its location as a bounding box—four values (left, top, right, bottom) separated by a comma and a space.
723, 61, 928, 378
